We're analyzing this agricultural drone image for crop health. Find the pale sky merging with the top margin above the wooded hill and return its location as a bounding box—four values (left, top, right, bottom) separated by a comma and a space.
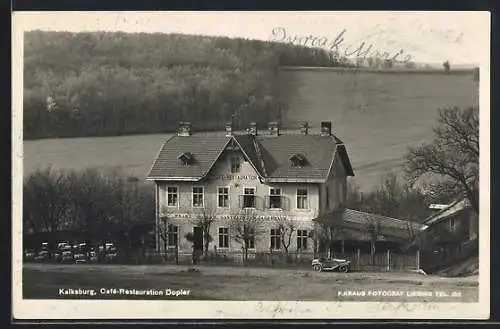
13, 11, 490, 65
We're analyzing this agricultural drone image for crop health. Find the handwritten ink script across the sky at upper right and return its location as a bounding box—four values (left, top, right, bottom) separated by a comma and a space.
271, 27, 413, 63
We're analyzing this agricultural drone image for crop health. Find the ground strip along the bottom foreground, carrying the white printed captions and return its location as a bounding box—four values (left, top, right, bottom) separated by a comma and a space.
23, 263, 478, 302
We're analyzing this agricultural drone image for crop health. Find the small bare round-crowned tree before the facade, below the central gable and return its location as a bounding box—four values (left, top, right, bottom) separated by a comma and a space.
229, 209, 264, 262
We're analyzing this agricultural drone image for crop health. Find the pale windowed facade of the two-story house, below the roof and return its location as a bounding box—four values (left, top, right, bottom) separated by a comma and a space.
155, 145, 346, 252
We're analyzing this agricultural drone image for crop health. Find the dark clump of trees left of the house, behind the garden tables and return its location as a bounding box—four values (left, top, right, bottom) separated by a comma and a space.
23, 168, 155, 250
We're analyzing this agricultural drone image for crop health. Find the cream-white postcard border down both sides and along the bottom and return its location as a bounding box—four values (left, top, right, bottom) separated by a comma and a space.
12, 12, 490, 320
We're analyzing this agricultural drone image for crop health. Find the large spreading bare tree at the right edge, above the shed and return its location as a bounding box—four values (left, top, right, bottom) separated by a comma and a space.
405, 107, 479, 213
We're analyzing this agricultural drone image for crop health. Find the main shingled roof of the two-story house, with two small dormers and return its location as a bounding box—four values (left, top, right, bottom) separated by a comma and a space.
147, 133, 354, 183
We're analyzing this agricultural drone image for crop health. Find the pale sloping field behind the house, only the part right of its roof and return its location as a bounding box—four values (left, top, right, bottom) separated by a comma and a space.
281, 68, 479, 189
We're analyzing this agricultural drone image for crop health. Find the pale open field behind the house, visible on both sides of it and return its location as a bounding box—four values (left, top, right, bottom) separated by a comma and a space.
24, 68, 478, 189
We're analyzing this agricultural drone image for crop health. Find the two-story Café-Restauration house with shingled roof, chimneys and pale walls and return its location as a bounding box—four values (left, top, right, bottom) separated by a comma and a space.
147, 122, 354, 252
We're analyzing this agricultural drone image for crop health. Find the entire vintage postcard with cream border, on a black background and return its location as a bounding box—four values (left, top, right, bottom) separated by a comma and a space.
12, 11, 490, 320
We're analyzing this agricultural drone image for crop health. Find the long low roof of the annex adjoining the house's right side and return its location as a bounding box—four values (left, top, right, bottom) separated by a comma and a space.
315, 209, 427, 239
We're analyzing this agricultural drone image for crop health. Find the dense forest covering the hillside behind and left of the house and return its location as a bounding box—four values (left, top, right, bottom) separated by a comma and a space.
23, 31, 349, 139
